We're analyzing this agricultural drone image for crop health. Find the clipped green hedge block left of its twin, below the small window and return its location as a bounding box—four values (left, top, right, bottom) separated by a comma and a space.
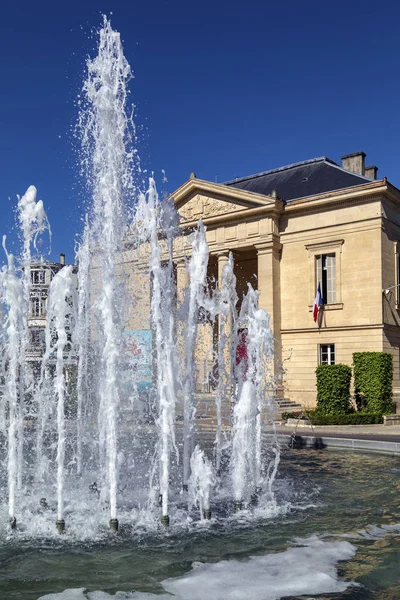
316, 364, 352, 415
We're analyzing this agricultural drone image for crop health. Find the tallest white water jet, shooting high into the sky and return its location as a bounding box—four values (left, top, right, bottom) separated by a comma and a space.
81, 17, 138, 519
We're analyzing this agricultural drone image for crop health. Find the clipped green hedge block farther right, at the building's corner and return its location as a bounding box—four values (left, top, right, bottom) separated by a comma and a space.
353, 352, 393, 414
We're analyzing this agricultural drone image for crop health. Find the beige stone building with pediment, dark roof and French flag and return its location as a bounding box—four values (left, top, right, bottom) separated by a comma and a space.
121, 152, 400, 407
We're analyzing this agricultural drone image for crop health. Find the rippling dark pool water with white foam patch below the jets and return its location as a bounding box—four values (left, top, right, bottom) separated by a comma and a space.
0, 450, 400, 600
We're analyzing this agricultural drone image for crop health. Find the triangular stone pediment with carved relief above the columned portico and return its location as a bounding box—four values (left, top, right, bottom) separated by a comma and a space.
172, 179, 276, 221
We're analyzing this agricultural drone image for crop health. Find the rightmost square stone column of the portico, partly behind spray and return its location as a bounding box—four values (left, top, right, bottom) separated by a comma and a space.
255, 235, 283, 397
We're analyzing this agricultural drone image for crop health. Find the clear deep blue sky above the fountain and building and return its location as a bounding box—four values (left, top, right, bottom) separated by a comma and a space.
0, 0, 400, 261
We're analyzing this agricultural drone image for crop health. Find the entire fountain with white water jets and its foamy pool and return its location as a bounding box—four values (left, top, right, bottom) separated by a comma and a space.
0, 18, 399, 600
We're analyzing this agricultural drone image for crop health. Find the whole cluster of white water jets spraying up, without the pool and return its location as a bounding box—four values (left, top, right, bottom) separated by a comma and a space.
0, 19, 279, 537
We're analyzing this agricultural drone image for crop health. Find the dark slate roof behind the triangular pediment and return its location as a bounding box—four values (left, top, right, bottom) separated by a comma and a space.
225, 156, 372, 202
